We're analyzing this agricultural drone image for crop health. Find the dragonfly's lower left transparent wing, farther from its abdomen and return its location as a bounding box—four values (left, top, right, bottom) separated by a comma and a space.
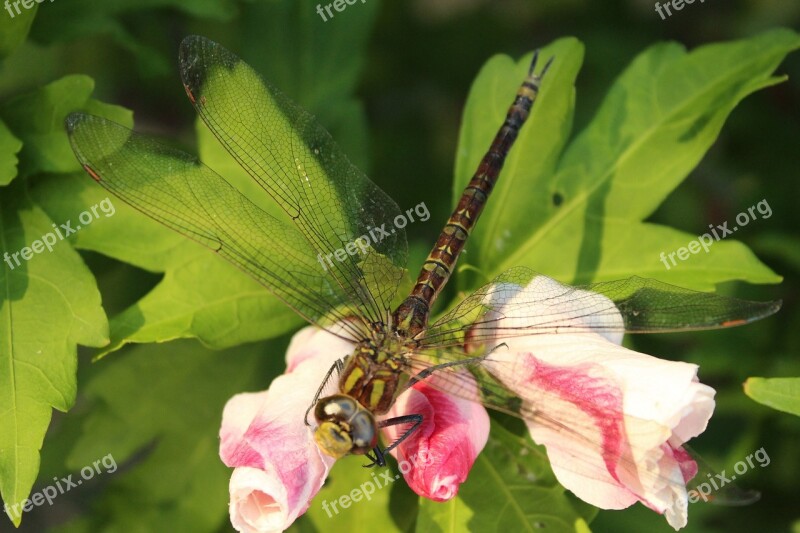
67, 113, 366, 340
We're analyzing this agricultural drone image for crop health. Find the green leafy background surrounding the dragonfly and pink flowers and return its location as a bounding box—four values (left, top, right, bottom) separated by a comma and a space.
0, 0, 800, 532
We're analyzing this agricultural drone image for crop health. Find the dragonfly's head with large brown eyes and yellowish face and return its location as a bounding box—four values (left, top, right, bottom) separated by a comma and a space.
314, 394, 378, 459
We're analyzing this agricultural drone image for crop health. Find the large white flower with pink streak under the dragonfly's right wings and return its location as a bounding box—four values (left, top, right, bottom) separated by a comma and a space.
476, 277, 714, 529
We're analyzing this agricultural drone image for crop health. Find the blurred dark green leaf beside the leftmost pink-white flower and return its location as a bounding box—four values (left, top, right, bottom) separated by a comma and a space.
57, 341, 285, 532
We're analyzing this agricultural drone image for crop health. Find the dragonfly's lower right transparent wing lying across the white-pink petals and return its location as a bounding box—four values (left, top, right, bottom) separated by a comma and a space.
406, 342, 760, 505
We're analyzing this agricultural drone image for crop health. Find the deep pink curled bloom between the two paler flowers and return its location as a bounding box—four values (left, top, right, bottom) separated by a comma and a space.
383, 371, 489, 501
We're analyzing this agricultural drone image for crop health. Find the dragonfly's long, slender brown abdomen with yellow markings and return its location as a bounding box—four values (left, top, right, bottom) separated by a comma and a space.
394, 55, 549, 337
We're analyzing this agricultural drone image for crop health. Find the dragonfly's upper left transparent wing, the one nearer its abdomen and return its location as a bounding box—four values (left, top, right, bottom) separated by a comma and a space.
180, 36, 407, 322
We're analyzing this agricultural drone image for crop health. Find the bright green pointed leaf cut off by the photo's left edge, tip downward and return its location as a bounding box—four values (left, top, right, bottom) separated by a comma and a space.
0, 180, 108, 525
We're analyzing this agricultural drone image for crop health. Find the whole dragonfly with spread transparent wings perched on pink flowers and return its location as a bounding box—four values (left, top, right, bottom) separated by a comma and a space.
66, 36, 780, 508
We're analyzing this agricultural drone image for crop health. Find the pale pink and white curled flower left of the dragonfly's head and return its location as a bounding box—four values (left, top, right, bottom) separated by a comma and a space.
220, 328, 354, 531
